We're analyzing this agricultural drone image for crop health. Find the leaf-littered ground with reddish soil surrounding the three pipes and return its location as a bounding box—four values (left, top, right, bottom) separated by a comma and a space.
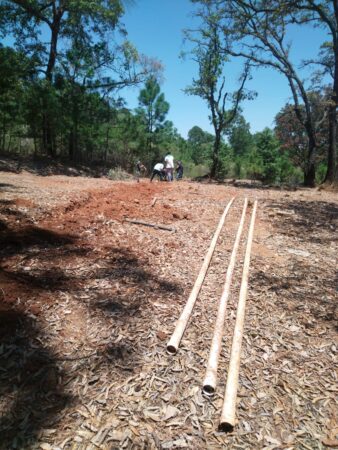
0, 172, 338, 450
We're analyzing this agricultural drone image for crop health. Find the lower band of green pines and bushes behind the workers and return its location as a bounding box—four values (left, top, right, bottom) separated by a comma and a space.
0, 44, 316, 183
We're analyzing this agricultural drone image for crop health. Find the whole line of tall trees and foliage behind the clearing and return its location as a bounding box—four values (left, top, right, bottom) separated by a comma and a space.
0, 0, 338, 186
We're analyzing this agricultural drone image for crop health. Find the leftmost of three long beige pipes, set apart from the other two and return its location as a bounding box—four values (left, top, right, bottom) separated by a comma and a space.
167, 197, 235, 355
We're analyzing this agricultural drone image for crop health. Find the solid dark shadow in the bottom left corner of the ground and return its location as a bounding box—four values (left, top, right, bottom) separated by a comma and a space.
0, 304, 72, 450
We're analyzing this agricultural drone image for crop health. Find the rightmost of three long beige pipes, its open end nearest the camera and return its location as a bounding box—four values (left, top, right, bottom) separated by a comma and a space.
219, 200, 257, 431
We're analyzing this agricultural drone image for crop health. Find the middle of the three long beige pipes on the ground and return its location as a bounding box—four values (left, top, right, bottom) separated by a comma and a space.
203, 198, 248, 395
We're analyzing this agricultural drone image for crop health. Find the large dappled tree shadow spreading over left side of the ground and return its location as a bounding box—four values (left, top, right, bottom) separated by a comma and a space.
0, 223, 182, 450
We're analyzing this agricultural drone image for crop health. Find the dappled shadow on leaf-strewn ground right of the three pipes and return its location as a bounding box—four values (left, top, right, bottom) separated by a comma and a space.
252, 200, 338, 327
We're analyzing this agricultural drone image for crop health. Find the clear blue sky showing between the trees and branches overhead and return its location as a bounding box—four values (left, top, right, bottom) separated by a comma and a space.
122, 0, 326, 137
